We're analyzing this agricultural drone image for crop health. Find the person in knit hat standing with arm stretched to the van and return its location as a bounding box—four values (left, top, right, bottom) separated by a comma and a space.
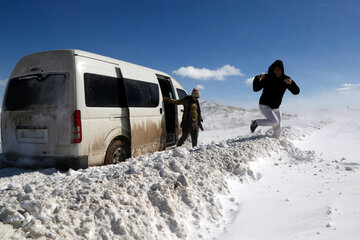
164, 88, 203, 147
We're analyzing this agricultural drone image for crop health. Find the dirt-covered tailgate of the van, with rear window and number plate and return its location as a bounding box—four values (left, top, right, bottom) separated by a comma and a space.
2, 72, 71, 156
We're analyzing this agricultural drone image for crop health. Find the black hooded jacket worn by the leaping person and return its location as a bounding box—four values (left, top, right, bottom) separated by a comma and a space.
253, 60, 300, 109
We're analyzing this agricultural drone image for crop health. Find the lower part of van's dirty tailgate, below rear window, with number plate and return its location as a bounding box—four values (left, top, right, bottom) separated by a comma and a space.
2, 111, 77, 156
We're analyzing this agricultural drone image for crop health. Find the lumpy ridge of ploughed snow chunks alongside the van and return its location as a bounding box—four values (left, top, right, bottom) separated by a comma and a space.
0, 126, 313, 239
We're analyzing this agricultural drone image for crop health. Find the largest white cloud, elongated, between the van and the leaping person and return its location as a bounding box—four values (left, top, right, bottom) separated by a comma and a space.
173, 64, 244, 81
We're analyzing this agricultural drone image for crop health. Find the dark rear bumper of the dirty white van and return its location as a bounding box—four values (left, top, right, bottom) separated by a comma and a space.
0, 153, 89, 170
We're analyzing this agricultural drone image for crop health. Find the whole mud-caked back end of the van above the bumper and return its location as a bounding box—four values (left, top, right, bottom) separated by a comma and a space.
1, 50, 76, 157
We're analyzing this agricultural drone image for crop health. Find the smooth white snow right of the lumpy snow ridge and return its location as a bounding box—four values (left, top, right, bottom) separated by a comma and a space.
219, 112, 360, 240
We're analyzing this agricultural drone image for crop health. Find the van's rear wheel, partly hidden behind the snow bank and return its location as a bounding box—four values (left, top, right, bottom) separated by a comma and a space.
105, 140, 129, 164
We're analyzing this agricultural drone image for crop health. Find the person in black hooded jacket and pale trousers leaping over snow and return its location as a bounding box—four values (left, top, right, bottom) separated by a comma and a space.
250, 60, 300, 138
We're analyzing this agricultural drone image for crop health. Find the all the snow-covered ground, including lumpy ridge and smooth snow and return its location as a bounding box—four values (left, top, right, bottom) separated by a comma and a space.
0, 102, 360, 240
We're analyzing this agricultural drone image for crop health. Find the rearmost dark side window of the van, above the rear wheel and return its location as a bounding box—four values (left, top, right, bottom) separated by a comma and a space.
84, 73, 126, 107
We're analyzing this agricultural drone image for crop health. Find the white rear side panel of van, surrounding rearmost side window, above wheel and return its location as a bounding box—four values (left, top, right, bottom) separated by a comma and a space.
75, 55, 129, 165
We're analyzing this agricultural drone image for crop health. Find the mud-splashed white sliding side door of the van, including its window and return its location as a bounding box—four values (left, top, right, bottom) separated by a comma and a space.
118, 67, 166, 157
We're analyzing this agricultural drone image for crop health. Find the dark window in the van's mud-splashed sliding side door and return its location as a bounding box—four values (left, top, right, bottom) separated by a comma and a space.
124, 78, 159, 107
